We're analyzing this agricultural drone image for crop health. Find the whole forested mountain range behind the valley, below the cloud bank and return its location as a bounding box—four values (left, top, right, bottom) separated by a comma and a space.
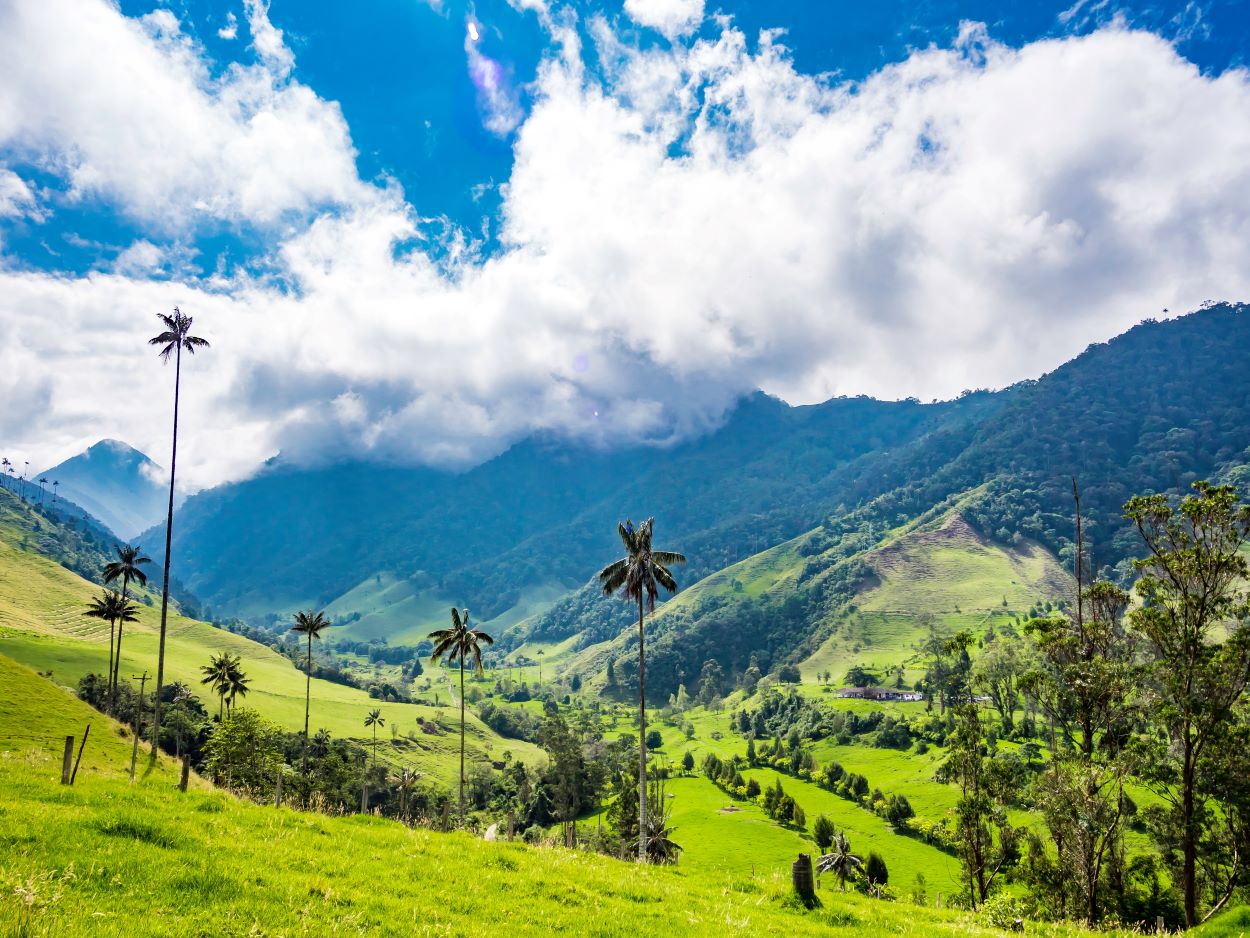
75, 304, 1250, 693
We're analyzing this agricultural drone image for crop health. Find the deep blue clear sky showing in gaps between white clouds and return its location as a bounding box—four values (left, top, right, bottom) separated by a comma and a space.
0, 0, 1250, 274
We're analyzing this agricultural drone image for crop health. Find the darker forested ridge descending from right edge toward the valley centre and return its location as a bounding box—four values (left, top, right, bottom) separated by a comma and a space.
525, 305, 1250, 695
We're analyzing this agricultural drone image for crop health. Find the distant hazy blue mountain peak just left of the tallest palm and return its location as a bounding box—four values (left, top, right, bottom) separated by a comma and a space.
39, 440, 169, 540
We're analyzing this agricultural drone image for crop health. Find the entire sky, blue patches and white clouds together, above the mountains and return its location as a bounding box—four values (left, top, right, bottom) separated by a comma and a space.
0, 0, 1250, 484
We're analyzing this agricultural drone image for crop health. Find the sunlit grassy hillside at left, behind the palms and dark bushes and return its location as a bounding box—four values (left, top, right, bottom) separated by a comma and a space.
0, 528, 543, 782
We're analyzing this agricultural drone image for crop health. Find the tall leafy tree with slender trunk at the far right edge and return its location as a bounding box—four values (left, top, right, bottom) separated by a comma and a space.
1124, 482, 1250, 928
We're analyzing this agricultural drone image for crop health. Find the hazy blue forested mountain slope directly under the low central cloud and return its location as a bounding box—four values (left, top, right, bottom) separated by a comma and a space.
153, 394, 999, 619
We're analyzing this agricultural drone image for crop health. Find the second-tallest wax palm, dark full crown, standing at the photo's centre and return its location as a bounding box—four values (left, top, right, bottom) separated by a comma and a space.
599, 518, 686, 863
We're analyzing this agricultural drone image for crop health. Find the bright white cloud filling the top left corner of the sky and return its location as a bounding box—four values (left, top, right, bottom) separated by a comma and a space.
0, 0, 364, 230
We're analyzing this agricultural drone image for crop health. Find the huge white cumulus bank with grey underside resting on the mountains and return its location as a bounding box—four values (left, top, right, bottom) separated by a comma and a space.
0, 5, 1250, 484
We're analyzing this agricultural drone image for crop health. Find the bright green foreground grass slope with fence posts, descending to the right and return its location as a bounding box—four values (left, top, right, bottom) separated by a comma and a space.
0, 658, 1115, 938
